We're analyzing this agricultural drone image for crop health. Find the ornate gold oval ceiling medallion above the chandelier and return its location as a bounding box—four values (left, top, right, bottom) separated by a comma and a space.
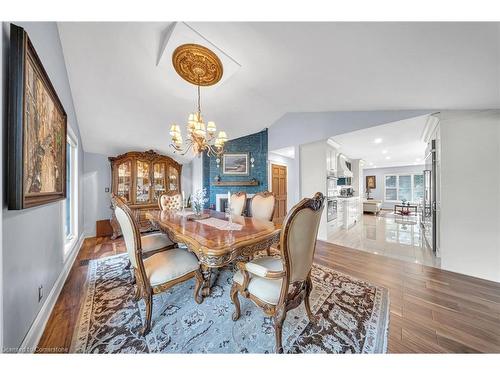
172, 44, 223, 86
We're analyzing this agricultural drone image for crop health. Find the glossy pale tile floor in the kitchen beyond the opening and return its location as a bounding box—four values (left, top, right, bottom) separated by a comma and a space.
328, 211, 441, 268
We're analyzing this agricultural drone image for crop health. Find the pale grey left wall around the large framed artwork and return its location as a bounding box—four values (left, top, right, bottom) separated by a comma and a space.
2, 22, 83, 348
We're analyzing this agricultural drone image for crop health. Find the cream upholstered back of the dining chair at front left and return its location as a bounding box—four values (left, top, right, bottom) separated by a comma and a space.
111, 194, 141, 268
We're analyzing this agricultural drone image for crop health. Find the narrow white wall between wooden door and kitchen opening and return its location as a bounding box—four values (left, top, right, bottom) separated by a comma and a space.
300, 139, 327, 240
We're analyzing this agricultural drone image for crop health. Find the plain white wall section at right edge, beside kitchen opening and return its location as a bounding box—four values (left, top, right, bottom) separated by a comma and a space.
439, 110, 500, 281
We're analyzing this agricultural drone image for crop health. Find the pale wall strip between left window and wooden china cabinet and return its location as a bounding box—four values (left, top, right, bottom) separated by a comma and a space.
83, 152, 112, 237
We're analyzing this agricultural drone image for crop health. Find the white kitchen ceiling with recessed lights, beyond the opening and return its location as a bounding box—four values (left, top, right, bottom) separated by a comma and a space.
331, 115, 429, 168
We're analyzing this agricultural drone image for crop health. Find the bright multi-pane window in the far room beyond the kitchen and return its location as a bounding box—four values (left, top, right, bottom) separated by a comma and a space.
384, 174, 424, 203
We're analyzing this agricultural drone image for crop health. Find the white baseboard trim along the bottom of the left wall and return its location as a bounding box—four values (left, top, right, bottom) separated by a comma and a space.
19, 233, 86, 353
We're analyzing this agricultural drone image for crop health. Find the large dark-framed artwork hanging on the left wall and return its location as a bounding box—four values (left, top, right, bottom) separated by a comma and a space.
7, 24, 67, 210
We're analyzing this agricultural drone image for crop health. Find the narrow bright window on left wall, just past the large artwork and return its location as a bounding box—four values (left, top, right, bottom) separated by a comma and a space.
64, 129, 78, 253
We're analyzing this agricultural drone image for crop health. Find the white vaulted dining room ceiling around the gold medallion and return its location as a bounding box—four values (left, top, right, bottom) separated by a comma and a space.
59, 22, 500, 161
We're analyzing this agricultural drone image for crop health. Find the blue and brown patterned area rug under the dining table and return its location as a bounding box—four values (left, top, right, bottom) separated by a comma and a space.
70, 254, 389, 353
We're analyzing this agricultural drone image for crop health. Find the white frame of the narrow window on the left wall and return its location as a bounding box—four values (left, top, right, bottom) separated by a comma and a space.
62, 127, 79, 259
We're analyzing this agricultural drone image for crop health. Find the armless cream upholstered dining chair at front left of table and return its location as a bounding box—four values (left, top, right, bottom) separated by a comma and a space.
115, 195, 203, 335
